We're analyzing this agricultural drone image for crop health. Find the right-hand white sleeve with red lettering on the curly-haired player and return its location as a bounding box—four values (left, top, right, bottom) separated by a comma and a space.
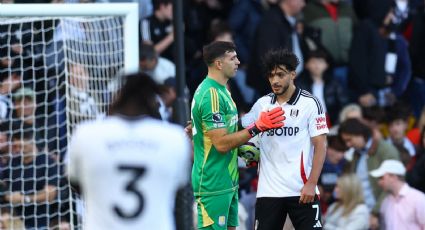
308, 97, 329, 137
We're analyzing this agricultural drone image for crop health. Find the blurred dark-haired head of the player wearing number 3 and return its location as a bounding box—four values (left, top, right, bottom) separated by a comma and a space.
109, 73, 161, 119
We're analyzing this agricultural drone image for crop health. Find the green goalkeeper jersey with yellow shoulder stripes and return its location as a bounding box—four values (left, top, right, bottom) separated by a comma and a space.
191, 76, 239, 196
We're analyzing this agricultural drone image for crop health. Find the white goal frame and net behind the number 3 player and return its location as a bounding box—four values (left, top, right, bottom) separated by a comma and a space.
0, 4, 138, 229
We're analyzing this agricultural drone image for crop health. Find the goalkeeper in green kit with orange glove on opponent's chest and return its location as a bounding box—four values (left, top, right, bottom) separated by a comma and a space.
191, 41, 285, 230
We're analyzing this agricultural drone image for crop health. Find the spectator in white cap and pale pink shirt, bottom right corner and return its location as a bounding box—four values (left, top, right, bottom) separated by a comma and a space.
370, 160, 425, 230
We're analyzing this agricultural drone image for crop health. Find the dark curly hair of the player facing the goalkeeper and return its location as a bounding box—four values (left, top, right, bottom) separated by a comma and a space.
263, 49, 300, 76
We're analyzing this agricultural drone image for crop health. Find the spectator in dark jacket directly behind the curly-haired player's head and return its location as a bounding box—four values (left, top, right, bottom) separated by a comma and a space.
247, 0, 306, 95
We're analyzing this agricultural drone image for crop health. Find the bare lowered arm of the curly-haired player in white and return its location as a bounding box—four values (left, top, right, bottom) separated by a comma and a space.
300, 134, 326, 203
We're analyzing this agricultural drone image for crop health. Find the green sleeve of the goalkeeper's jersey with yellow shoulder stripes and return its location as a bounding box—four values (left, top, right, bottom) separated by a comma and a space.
199, 88, 227, 131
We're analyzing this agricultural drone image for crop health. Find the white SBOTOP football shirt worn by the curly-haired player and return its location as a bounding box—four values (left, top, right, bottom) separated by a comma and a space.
241, 88, 329, 197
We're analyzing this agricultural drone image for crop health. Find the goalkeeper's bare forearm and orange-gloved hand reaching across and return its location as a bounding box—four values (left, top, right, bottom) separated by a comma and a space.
206, 107, 285, 153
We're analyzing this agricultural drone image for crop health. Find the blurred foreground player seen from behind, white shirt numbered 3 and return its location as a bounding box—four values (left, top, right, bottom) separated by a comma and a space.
68, 74, 190, 230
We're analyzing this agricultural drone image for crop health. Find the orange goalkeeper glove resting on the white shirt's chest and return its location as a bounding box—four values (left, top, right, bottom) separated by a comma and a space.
247, 106, 285, 137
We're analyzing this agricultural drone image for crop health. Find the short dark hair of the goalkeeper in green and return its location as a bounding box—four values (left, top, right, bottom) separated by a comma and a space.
202, 41, 236, 66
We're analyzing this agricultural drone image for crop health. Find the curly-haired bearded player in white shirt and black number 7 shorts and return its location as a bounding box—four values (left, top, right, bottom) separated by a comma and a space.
238, 49, 328, 230
